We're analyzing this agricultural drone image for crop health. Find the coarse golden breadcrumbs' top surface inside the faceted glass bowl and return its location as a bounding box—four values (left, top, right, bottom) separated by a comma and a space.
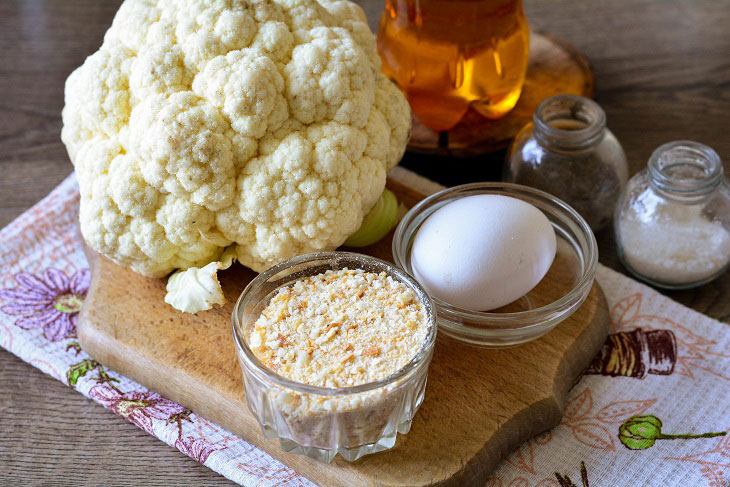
249, 269, 428, 387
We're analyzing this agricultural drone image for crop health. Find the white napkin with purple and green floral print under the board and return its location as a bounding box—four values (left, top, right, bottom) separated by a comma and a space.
0, 176, 730, 487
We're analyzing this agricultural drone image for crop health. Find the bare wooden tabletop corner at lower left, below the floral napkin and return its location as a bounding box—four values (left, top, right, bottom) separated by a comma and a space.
0, 352, 236, 487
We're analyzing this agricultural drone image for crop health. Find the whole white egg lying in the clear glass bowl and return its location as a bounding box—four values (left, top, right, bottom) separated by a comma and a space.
411, 194, 557, 311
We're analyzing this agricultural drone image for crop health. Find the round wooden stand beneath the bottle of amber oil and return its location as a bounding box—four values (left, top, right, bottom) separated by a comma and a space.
408, 32, 594, 158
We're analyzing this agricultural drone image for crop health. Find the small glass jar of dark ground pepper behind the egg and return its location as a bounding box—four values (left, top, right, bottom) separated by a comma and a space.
503, 95, 629, 231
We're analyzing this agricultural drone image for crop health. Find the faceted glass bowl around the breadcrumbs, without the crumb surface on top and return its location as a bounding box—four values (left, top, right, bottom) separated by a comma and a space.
232, 252, 436, 462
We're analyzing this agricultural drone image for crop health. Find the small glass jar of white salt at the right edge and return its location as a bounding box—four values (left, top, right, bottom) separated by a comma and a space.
614, 140, 730, 289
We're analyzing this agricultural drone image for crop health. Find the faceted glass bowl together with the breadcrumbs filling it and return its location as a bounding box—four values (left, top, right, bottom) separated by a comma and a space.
233, 252, 436, 462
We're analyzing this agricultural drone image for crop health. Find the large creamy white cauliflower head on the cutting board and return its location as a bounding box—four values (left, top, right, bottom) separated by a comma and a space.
62, 0, 411, 277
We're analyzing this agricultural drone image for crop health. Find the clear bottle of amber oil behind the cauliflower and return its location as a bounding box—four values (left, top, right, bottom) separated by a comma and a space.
378, 0, 529, 131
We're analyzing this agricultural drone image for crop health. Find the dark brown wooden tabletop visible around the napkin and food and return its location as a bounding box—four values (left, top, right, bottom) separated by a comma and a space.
0, 0, 730, 485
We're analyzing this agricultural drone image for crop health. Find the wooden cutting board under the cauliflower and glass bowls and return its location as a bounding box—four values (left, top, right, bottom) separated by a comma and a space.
78, 168, 609, 487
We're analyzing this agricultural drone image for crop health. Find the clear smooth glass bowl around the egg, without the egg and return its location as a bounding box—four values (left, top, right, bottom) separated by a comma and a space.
393, 183, 598, 347
